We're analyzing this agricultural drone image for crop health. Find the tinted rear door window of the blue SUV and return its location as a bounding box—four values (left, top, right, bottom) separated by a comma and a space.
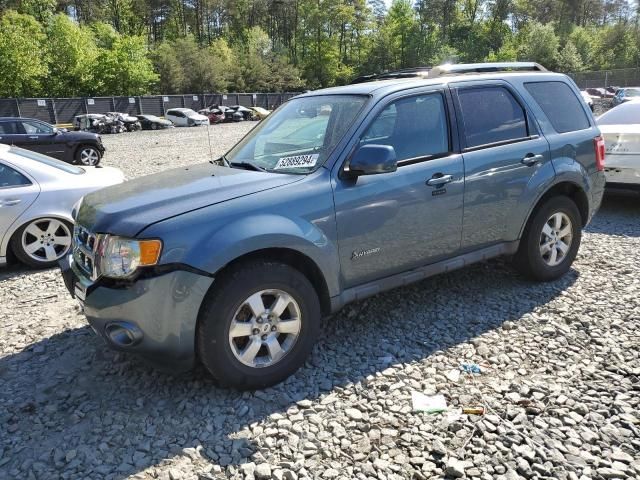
458, 87, 528, 148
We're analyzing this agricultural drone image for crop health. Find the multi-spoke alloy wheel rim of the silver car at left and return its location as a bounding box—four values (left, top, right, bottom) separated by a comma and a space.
21, 218, 71, 263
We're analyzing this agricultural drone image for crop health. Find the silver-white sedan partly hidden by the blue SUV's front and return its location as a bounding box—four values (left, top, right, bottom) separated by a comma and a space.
0, 145, 124, 268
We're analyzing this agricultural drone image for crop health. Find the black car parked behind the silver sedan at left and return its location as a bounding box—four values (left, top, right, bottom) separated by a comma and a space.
0, 117, 105, 166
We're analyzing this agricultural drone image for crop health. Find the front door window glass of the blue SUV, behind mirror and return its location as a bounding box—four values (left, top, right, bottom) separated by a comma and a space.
360, 93, 450, 162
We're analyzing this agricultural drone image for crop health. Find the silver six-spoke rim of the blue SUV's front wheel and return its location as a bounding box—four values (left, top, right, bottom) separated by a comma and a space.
229, 289, 302, 368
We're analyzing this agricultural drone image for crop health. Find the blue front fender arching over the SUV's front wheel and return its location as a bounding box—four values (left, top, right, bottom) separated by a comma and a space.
147, 213, 340, 296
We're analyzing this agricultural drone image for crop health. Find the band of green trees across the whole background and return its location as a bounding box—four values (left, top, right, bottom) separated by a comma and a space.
0, 0, 640, 96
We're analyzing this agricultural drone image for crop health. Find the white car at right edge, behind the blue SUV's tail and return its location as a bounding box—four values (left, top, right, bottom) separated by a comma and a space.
596, 100, 640, 190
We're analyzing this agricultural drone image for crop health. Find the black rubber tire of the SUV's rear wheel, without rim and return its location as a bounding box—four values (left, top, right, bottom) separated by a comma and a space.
514, 196, 582, 282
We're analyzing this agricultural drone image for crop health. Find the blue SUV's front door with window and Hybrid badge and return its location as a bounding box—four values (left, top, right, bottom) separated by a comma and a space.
334, 89, 464, 288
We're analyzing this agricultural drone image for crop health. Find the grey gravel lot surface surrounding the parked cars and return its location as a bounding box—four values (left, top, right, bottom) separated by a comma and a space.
0, 124, 640, 480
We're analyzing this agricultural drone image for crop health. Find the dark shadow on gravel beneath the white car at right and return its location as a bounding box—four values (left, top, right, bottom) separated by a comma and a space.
586, 193, 640, 237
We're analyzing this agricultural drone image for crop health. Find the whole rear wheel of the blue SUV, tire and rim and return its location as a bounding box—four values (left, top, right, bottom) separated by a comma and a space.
514, 196, 582, 281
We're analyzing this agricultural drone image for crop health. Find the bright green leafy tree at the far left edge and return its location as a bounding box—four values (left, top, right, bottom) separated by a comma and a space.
0, 10, 48, 97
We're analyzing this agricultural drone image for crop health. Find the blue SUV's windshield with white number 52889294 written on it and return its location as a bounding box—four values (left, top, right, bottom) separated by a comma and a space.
227, 95, 367, 173
